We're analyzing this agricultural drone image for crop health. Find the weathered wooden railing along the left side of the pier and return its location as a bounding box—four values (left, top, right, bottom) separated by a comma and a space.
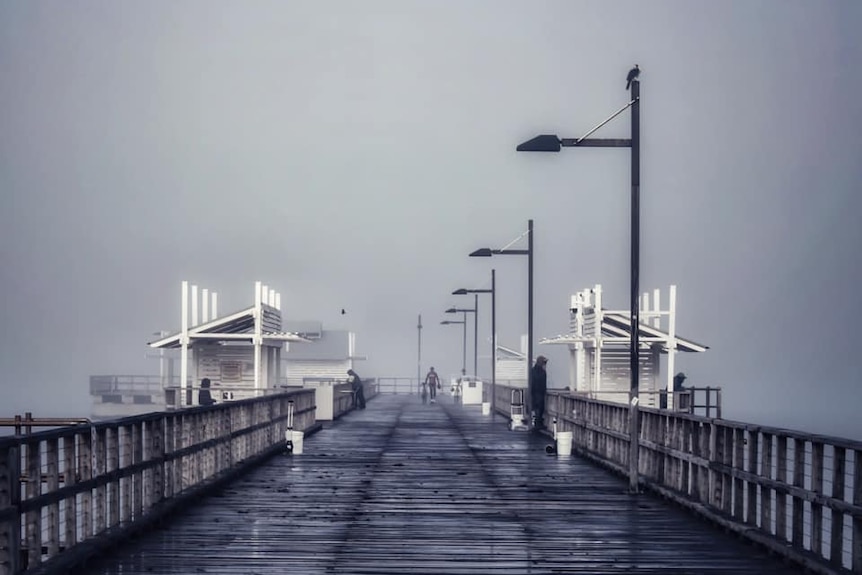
0, 389, 315, 575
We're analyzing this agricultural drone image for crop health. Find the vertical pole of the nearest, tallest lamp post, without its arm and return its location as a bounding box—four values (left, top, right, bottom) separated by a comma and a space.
629, 80, 640, 493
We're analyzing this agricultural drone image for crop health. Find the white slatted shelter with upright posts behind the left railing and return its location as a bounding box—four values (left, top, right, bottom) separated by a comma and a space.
149, 281, 309, 408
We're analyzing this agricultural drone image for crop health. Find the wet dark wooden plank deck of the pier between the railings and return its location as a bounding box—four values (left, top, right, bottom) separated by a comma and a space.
81, 396, 801, 575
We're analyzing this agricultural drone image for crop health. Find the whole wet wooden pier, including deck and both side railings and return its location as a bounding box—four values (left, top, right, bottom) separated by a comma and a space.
0, 389, 862, 575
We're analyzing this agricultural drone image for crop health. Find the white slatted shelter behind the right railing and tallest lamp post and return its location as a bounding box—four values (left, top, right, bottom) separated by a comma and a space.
540, 284, 708, 409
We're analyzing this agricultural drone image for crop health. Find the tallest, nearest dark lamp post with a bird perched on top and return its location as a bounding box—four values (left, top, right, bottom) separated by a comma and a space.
517, 73, 640, 492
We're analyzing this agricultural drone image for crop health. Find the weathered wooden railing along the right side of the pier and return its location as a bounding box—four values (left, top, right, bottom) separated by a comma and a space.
548, 389, 862, 573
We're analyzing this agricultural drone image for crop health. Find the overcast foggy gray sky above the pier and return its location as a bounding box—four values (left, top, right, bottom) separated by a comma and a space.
5, 0, 862, 437
